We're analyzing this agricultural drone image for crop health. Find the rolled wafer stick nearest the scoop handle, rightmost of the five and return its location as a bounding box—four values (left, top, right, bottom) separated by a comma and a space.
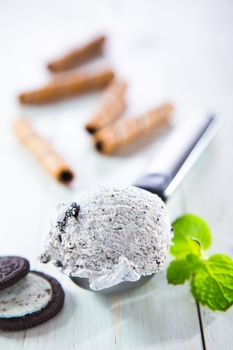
93, 103, 173, 154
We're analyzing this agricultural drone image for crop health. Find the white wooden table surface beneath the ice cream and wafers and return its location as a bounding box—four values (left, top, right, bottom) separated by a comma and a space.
0, 0, 233, 350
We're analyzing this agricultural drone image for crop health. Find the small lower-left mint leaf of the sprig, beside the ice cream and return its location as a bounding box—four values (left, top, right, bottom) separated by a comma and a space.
167, 259, 192, 284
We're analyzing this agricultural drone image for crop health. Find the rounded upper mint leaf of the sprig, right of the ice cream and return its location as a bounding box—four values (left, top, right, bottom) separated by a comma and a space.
170, 214, 211, 259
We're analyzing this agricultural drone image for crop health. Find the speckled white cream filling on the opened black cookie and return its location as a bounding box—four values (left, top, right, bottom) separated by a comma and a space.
0, 272, 52, 318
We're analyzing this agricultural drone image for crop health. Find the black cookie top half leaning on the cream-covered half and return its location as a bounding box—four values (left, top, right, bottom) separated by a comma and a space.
0, 256, 30, 290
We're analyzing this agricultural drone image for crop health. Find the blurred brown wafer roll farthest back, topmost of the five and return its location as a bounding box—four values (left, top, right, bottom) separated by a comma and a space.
48, 36, 106, 73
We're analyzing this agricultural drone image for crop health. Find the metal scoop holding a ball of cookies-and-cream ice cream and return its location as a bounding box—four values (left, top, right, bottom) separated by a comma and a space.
41, 116, 219, 294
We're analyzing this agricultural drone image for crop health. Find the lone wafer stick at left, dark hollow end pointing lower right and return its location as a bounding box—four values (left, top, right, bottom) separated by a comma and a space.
13, 118, 74, 184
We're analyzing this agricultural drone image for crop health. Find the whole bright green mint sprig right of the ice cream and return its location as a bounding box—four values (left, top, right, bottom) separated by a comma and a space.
167, 214, 233, 311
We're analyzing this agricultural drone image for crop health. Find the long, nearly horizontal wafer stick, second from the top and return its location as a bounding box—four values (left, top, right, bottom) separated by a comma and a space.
19, 69, 114, 104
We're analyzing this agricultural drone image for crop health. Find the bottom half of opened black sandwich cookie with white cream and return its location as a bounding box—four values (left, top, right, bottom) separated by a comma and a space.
0, 271, 65, 331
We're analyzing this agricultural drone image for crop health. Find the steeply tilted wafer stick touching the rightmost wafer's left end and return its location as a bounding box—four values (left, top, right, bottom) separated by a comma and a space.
86, 81, 126, 134
